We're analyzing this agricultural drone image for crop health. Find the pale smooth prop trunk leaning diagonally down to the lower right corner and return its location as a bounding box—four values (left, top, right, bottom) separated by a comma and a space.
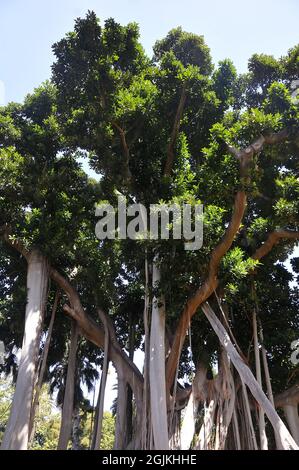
202, 303, 299, 450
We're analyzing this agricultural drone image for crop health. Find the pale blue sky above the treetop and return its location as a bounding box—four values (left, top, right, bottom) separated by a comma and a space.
0, 0, 299, 104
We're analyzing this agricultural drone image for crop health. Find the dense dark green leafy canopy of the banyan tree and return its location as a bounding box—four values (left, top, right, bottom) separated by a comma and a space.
0, 12, 299, 452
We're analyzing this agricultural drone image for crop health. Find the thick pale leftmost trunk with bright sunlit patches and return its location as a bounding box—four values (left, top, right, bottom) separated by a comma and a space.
1, 250, 48, 450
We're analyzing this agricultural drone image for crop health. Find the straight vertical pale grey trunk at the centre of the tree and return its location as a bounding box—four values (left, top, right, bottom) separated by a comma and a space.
150, 258, 169, 450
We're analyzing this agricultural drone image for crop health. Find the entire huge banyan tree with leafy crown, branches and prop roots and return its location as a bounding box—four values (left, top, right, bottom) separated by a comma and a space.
0, 12, 299, 450
